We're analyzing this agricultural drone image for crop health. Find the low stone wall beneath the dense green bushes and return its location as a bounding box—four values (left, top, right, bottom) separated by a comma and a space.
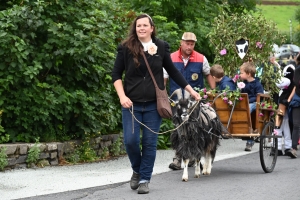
0, 134, 120, 170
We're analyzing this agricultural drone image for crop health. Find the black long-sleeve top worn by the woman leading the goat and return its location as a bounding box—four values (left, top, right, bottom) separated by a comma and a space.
112, 38, 188, 102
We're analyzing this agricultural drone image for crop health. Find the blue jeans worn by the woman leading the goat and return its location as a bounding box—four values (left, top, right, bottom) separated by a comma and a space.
122, 101, 162, 183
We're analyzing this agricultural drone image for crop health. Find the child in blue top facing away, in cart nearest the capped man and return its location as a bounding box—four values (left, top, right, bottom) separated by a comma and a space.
210, 64, 236, 91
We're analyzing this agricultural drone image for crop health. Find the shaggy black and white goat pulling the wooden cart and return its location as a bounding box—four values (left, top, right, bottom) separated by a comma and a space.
171, 89, 224, 181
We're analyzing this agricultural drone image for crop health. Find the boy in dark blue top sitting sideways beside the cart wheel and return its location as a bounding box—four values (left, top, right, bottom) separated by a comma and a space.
240, 62, 264, 151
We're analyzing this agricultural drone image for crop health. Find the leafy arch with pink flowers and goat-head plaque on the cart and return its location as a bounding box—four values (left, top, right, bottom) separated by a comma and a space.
208, 13, 285, 95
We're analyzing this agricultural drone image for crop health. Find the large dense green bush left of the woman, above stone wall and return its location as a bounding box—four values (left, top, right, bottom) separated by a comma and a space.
0, 0, 131, 142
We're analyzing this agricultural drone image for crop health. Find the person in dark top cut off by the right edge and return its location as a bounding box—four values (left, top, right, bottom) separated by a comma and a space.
288, 54, 300, 158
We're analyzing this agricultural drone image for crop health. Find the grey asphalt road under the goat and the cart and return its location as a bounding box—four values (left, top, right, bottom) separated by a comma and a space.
13, 140, 300, 200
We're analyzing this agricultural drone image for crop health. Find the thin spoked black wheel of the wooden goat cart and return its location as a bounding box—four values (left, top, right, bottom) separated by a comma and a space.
259, 122, 278, 173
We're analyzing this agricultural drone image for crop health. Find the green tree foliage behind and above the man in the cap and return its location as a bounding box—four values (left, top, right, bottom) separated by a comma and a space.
120, 0, 257, 62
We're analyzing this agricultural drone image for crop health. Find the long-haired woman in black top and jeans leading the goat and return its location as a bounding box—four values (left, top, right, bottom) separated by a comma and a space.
112, 14, 201, 194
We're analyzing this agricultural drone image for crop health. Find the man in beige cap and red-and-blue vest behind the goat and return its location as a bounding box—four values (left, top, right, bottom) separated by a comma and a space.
164, 32, 215, 170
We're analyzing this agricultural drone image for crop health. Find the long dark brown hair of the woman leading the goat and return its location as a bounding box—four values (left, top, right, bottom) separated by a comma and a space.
122, 14, 156, 67
